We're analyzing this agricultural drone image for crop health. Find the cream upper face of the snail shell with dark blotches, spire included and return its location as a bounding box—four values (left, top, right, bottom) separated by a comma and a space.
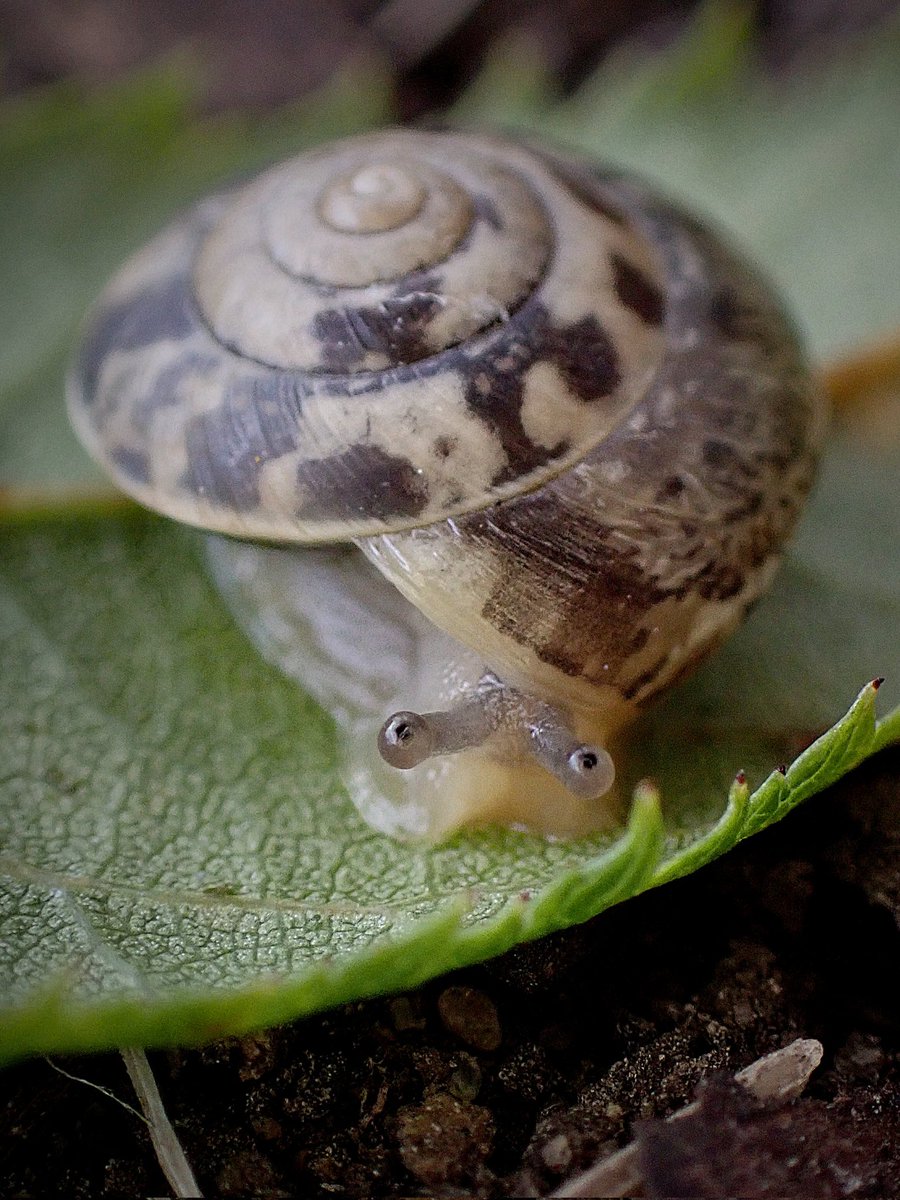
70, 131, 666, 541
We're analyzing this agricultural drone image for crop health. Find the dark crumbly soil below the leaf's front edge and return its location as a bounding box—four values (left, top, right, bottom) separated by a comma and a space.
0, 751, 900, 1198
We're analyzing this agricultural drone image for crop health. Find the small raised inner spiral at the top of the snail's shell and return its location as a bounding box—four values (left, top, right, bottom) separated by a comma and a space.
193, 138, 553, 364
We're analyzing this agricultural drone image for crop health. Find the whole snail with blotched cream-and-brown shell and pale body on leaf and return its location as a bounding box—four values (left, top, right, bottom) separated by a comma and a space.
68, 130, 826, 836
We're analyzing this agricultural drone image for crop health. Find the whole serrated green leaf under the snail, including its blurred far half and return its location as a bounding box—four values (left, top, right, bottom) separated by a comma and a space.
0, 7, 900, 1058
